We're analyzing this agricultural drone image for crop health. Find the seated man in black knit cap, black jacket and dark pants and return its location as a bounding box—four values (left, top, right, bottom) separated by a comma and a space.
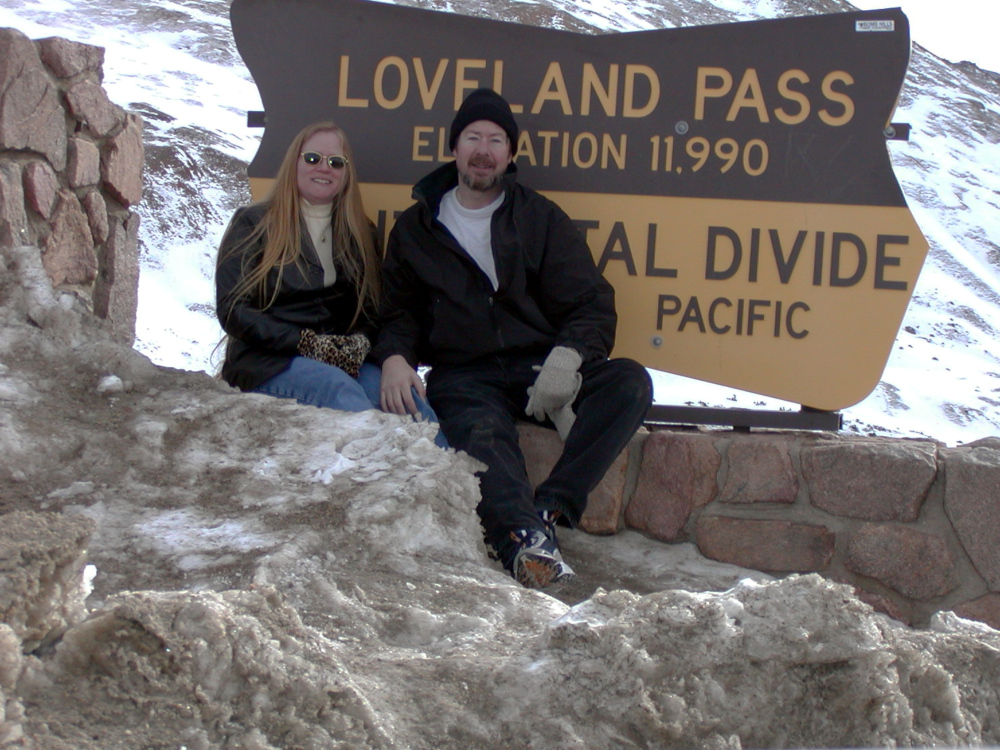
372, 89, 652, 588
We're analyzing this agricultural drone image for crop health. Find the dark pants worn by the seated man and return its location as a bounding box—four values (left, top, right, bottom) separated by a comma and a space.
427, 356, 653, 545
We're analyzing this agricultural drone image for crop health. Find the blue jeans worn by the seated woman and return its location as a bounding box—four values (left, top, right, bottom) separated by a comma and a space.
253, 357, 448, 448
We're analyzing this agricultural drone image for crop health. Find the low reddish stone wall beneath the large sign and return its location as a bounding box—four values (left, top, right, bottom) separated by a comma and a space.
521, 424, 1000, 629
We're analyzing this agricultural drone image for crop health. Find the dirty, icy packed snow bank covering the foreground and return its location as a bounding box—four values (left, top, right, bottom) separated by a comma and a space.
0, 247, 1000, 750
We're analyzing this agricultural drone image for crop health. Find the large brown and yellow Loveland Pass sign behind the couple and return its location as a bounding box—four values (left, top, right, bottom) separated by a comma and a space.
230, 0, 927, 411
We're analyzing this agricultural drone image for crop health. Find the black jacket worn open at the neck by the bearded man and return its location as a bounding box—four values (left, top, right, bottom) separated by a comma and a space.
371, 163, 617, 367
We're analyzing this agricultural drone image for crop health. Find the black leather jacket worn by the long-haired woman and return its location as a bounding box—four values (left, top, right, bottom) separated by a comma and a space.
215, 204, 378, 391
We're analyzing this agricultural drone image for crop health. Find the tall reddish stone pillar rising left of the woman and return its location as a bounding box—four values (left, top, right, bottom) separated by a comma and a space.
0, 29, 143, 345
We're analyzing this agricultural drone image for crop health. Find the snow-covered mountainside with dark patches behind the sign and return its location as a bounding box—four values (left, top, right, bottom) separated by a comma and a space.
0, 0, 1000, 444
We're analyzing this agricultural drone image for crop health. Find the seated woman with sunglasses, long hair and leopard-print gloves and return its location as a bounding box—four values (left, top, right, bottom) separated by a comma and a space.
215, 122, 443, 432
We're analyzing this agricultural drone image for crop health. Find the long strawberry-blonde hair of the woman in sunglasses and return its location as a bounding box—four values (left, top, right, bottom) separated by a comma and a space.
219, 121, 381, 326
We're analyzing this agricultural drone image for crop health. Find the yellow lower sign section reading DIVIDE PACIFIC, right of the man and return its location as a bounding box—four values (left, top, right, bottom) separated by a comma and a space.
552, 194, 927, 411
